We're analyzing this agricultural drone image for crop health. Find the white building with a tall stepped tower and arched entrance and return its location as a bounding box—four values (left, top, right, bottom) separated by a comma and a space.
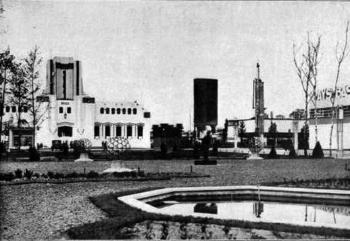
4, 57, 151, 148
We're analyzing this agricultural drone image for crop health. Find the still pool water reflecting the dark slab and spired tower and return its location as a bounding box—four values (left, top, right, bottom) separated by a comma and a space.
154, 201, 350, 228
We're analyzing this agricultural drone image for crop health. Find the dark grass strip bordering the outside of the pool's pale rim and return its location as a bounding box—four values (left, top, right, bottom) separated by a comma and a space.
65, 187, 350, 239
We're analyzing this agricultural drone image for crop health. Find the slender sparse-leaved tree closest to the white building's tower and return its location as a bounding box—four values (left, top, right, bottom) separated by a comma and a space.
24, 46, 47, 147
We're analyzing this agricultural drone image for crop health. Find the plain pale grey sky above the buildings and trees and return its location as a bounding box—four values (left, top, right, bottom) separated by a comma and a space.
0, 0, 350, 129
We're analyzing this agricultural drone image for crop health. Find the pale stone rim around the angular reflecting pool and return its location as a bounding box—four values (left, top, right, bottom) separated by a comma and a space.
118, 185, 350, 230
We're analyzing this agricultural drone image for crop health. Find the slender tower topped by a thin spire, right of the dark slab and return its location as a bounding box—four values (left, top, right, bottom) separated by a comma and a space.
253, 63, 265, 136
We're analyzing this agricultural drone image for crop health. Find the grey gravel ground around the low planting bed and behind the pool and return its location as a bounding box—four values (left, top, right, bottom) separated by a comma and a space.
0, 159, 349, 240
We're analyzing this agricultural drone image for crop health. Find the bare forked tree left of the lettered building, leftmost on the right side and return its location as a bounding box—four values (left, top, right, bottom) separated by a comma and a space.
293, 33, 321, 156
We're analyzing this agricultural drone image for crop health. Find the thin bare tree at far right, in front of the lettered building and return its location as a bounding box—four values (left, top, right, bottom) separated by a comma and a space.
329, 21, 350, 156
